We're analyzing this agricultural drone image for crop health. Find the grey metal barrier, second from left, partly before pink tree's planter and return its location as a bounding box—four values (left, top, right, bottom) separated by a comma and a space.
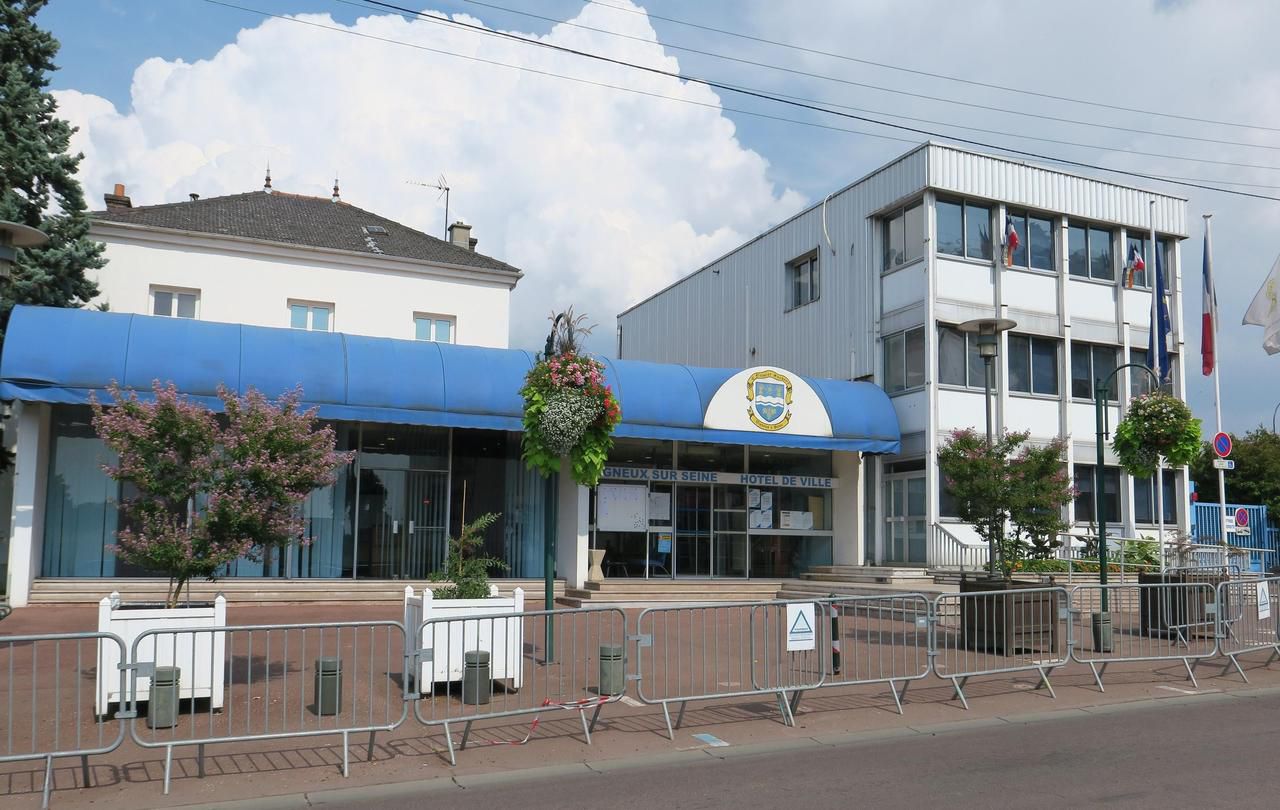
116, 622, 408, 793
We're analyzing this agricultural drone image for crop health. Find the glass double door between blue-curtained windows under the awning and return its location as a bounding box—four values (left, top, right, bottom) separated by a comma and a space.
356, 468, 449, 580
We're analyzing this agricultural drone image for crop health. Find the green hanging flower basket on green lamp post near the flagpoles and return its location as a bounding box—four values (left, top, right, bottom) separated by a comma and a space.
1111, 392, 1201, 479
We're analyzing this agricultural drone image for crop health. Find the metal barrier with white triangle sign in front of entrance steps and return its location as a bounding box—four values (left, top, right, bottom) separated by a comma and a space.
632, 599, 831, 740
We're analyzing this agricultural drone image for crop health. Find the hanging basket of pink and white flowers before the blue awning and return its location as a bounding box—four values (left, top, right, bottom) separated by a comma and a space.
520, 351, 622, 486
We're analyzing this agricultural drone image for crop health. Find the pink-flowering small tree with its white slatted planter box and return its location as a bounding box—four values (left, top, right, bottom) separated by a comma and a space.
91, 381, 352, 714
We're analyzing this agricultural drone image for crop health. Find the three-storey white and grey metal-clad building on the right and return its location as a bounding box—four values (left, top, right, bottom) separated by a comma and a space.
618, 143, 1189, 563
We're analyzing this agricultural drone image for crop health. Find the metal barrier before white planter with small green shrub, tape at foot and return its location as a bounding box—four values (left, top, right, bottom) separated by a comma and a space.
406, 605, 627, 764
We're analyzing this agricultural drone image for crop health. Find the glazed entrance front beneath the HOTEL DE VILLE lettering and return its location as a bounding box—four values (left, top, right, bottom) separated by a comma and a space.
590, 439, 833, 578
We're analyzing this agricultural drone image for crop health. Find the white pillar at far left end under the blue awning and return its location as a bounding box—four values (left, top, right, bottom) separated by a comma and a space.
9, 402, 49, 608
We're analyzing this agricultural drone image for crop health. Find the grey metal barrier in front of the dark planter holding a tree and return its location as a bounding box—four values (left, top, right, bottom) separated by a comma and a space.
931, 587, 1071, 709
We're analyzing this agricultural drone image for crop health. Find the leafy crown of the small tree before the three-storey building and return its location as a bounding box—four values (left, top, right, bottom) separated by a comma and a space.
938, 429, 1075, 578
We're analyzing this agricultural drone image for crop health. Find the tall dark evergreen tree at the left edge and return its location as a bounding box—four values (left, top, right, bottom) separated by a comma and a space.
0, 0, 106, 340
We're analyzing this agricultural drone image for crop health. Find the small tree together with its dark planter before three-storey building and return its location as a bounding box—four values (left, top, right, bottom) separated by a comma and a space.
938, 430, 1074, 654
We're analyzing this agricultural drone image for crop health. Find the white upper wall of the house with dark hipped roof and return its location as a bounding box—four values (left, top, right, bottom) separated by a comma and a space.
91, 220, 520, 348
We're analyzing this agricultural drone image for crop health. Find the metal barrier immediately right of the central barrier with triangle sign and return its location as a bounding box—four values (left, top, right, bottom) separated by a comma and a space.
818, 594, 932, 714
